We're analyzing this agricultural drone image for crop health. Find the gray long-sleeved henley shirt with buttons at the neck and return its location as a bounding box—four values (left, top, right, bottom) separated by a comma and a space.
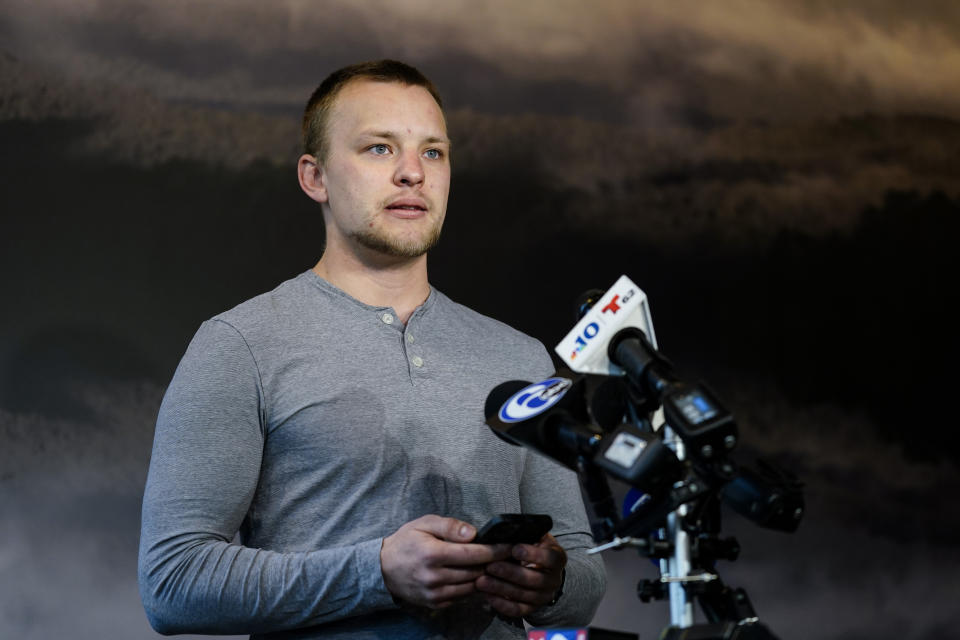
139, 271, 605, 640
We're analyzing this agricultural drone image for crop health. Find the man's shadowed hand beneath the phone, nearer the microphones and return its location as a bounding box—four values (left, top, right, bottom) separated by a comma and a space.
476, 533, 567, 618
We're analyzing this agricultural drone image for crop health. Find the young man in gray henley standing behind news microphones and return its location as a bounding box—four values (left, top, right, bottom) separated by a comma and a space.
140, 60, 604, 639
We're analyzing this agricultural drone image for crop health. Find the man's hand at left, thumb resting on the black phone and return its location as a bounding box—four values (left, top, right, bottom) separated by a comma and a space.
380, 515, 512, 609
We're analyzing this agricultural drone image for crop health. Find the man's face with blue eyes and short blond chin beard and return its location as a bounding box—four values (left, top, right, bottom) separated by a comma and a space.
321, 80, 450, 257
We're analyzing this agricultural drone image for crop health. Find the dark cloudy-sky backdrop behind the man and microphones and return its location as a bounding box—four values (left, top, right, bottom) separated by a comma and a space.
0, 0, 960, 640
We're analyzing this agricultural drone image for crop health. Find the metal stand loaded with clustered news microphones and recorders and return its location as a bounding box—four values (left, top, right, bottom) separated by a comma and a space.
524, 276, 803, 640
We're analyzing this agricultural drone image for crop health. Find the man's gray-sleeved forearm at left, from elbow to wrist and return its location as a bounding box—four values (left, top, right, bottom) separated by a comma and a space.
140, 534, 395, 634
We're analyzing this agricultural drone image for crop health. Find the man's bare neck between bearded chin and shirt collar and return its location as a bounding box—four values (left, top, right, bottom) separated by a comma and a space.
313, 247, 430, 324
